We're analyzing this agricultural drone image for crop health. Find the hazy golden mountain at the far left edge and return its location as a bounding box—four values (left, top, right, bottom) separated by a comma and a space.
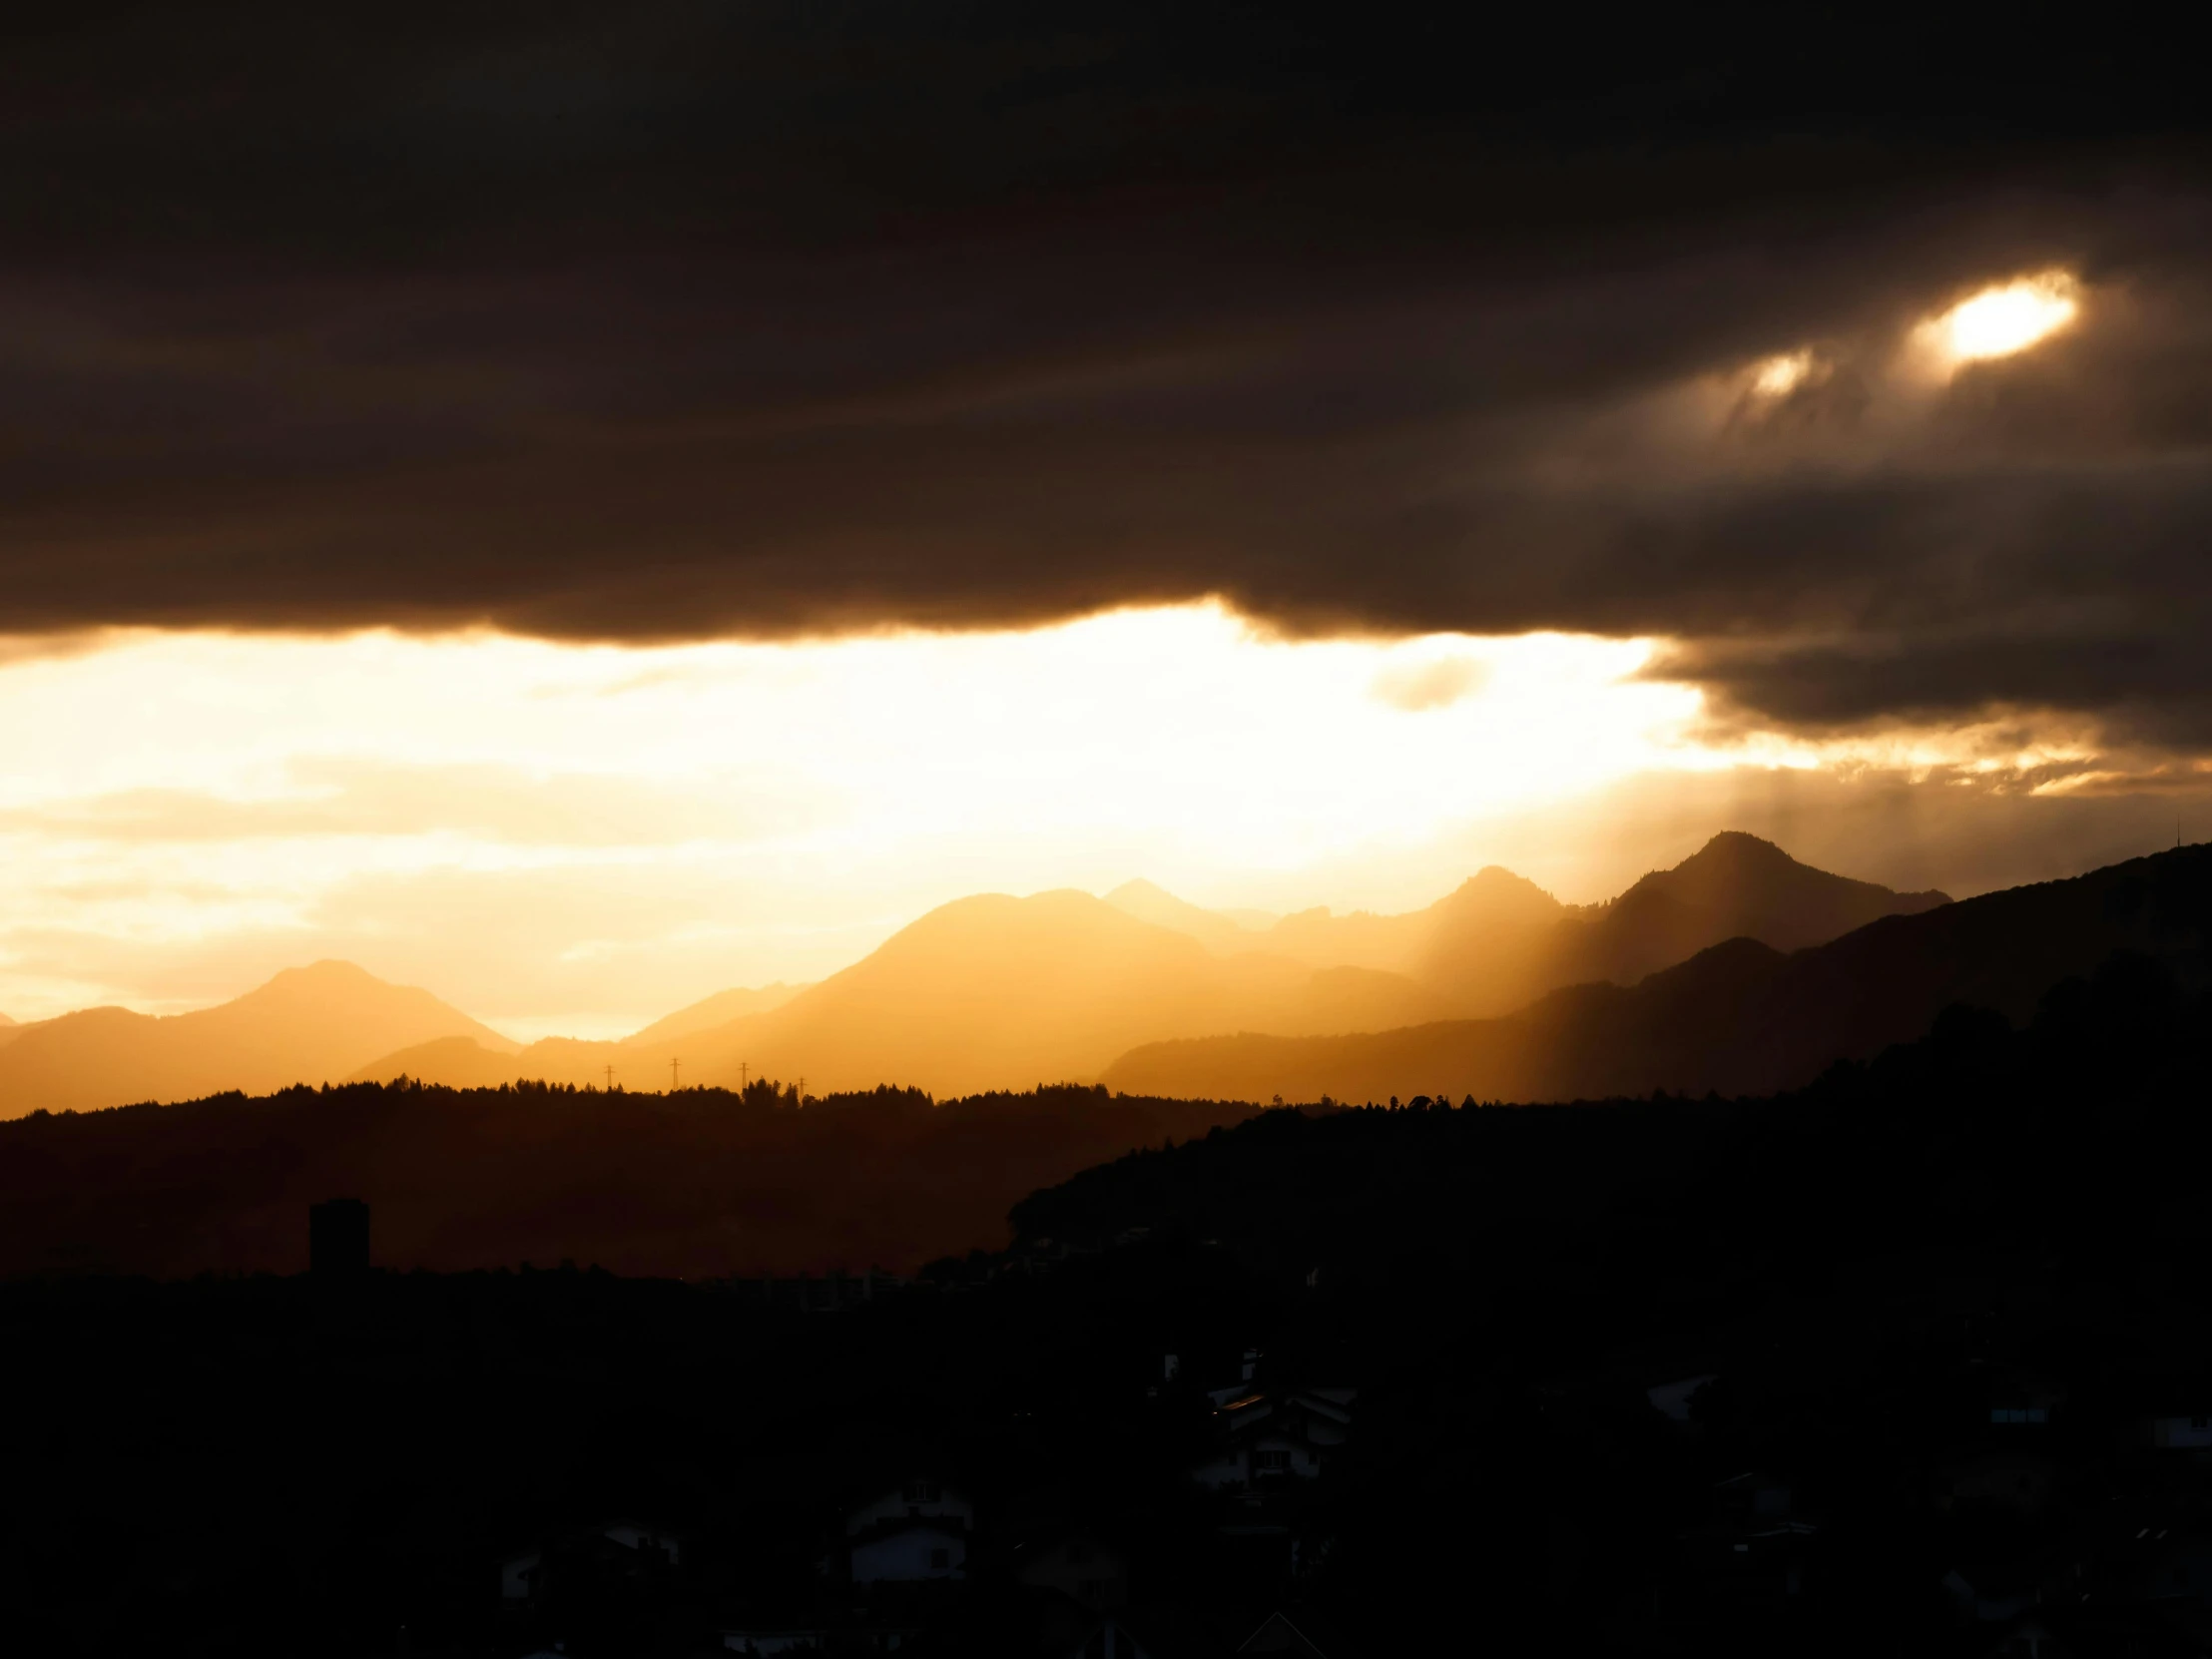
0, 962, 515, 1117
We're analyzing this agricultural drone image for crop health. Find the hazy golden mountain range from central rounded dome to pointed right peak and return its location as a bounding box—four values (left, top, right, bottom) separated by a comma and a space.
335, 833, 1946, 1119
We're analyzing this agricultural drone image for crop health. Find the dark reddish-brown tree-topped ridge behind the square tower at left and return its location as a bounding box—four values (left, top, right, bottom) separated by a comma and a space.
0, 1082, 1252, 1277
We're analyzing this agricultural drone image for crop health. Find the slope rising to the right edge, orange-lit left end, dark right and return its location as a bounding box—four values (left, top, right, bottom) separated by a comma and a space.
1104, 847, 2212, 1102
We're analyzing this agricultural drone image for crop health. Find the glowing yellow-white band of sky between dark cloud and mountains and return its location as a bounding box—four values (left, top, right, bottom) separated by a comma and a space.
0, 606, 1703, 1033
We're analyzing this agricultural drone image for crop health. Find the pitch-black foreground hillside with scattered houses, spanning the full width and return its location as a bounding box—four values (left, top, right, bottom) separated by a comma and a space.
0, 937, 2212, 1659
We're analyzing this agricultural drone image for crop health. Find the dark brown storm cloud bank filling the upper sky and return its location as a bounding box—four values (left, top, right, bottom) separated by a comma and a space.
0, 4, 2212, 746
